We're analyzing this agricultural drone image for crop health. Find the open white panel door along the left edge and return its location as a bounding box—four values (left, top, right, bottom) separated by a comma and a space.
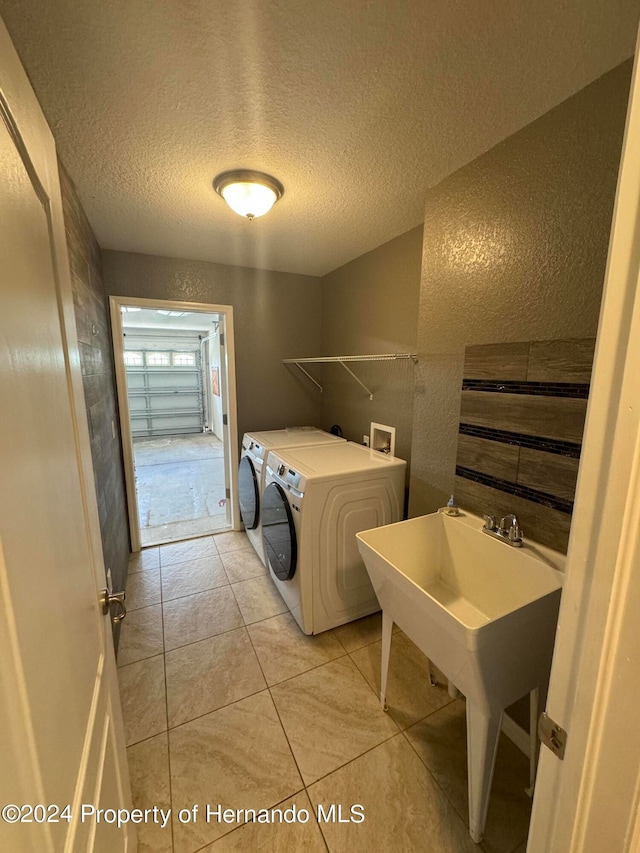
0, 21, 135, 853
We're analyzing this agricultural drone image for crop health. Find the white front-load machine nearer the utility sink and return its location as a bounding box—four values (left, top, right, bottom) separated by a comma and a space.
262, 442, 407, 634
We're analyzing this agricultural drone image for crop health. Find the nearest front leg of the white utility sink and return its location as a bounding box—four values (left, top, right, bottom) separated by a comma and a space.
467, 700, 502, 844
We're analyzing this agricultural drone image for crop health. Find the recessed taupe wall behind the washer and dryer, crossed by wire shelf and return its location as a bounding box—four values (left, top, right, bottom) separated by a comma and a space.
322, 225, 422, 480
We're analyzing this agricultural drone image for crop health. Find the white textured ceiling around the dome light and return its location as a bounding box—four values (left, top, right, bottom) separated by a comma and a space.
0, 0, 639, 275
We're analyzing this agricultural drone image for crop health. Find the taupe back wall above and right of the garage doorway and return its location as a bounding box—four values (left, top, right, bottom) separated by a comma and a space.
103, 251, 321, 446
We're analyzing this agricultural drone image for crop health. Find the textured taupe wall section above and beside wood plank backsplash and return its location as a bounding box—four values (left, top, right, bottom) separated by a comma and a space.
410, 62, 631, 515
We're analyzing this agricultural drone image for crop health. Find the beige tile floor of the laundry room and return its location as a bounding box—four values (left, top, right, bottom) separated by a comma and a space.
118, 533, 530, 853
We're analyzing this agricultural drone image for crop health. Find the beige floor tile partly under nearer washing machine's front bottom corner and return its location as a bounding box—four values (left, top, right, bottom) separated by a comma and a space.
247, 613, 345, 685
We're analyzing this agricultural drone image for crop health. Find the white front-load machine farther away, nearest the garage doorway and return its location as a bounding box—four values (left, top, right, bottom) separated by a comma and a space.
238, 427, 346, 566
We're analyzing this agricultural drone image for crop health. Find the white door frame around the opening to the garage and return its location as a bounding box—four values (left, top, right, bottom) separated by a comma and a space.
109, 296, 240, 553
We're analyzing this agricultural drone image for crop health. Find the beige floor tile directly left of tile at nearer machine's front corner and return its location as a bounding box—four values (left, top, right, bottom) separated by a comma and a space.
166, 628, 266, 728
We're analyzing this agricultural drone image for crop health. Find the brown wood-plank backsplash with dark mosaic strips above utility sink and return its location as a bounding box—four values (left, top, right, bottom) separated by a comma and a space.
456, 338, 595, 553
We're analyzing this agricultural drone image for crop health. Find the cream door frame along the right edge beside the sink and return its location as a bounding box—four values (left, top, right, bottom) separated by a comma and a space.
527, 26, 640, 853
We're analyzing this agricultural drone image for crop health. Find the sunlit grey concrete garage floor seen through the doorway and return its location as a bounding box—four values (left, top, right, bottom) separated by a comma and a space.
133, 433, 229, 547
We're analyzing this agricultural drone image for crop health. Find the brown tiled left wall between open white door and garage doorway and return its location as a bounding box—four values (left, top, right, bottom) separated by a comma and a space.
59, 164, 129, 640
